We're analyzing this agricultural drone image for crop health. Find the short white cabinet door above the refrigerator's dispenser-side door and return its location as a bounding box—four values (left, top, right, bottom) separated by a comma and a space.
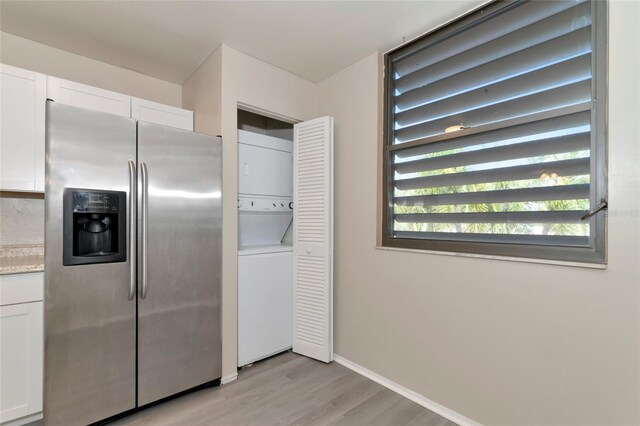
47, 76, 131, 117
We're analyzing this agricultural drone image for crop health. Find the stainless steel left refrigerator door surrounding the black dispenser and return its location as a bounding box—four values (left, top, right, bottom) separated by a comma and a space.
44, 102, 136, 425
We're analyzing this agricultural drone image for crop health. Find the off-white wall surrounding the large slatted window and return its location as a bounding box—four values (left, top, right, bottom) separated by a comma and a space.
318, 1, 640, 425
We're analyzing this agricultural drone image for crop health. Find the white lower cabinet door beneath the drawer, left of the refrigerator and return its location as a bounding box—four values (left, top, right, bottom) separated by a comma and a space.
0, 302, 43, 422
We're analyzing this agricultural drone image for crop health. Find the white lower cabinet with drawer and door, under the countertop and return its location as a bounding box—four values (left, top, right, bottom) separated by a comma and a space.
0, 273, 44, 424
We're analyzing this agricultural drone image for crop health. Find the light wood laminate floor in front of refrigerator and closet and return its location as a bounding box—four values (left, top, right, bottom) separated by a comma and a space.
111, 352, 455, 426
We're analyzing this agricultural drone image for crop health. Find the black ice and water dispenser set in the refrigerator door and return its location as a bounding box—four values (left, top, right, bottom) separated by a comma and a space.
62, 188, 127, 266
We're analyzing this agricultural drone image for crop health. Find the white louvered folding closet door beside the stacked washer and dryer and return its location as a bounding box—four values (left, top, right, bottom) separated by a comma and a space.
293, 117, 333, 362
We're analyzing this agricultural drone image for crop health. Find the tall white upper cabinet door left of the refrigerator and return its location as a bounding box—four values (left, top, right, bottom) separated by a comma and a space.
0, 65, 46, 191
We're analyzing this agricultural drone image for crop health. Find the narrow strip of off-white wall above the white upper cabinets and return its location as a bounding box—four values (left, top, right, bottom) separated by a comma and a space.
0, 32, 182, 107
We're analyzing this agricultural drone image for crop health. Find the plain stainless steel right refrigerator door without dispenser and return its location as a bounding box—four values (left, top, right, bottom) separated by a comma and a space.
138, 122, 222, 406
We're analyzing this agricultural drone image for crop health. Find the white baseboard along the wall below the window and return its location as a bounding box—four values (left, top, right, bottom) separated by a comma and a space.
333, 353, 480, 426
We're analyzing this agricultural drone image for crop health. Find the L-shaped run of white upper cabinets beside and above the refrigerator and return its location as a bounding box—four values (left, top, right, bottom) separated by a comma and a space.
0, 64, 193, 192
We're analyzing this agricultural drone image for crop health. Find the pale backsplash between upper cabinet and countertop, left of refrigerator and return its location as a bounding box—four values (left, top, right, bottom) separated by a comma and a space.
0, 197, 44, 245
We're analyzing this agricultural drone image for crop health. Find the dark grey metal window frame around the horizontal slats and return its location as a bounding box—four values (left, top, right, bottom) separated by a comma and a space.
379, 0, 608, 265
